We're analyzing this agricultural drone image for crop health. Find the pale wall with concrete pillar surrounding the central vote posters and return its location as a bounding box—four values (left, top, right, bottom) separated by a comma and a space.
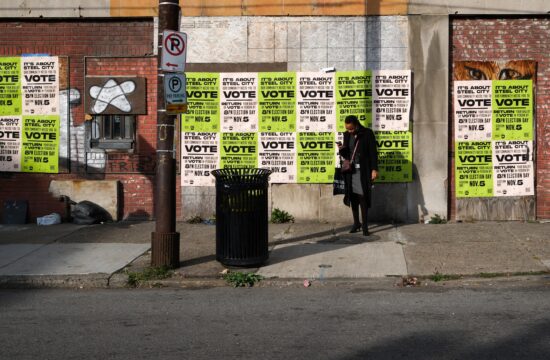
182, 16, 449, 222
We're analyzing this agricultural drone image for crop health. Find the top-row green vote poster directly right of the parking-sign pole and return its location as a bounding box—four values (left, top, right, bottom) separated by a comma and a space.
181, 73, 220, 132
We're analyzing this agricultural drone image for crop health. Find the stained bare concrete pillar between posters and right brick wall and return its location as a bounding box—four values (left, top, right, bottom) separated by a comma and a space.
407, 16, 449, 221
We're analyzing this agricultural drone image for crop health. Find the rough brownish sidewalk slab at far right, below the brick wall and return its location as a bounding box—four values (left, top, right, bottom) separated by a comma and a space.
402, 222, 550, 276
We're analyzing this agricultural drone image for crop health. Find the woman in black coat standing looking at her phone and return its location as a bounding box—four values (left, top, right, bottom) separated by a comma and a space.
339, 115, 378, 236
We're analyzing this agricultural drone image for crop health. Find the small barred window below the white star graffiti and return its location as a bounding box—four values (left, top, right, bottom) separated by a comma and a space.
90, 115, 135, 149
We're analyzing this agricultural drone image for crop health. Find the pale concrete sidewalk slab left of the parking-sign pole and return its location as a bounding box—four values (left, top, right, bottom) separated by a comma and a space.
0, 243, 150, 276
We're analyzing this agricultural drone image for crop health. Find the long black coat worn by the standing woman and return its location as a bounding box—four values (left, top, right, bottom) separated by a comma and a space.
339, 126, 378, 207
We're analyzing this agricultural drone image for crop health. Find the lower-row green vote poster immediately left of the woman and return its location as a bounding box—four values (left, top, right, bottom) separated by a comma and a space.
297, 132, 335, 184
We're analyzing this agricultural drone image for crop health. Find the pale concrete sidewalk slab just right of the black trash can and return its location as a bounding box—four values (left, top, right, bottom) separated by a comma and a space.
258, 242, 407, 279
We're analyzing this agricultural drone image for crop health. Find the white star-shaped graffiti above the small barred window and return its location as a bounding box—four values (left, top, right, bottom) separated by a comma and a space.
90, 79, 136, 114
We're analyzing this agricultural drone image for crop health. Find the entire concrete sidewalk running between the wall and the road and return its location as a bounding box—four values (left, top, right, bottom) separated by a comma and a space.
0, 218, 550, 287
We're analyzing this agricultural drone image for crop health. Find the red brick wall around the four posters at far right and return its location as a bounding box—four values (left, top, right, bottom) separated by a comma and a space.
449, 17, 550, 219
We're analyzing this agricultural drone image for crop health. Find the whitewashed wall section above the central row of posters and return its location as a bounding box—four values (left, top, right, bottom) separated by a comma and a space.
181, 16, 409, 71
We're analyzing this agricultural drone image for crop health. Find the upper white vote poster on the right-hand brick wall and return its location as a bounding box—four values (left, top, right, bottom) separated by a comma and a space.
454, 80, 493, 141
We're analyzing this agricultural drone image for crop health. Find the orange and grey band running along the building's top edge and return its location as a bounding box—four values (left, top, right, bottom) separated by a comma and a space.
0, 0, 550, 18
